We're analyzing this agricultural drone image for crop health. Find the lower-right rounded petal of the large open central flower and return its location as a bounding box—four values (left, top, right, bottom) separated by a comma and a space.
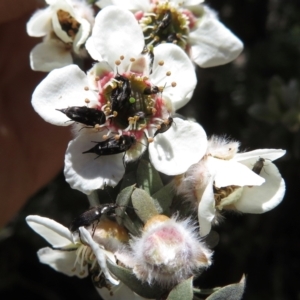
149, 118, 207, 176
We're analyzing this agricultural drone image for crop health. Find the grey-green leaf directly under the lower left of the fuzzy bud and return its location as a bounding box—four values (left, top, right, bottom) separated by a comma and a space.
107, 260, 165, 299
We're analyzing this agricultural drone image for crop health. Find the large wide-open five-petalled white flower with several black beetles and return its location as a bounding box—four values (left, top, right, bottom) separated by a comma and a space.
32, 7, 207, 194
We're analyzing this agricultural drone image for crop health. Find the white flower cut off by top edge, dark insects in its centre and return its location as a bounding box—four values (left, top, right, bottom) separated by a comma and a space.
96, 0, 243, 68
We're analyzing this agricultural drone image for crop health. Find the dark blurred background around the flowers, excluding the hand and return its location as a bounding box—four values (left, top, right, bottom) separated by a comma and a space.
0, 0, 300, 300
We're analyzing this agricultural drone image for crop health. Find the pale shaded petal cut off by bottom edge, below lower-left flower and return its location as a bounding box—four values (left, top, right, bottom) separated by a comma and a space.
97, 282, 154, 300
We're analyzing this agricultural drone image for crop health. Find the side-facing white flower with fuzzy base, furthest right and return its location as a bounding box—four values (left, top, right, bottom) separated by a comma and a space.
174, 137, 285, 236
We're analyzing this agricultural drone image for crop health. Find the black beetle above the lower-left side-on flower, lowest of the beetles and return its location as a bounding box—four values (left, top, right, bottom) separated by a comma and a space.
69, 203, 119, 232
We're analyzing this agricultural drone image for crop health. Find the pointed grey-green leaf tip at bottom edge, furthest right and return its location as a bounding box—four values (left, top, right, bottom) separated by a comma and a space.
206, 275, 246, 300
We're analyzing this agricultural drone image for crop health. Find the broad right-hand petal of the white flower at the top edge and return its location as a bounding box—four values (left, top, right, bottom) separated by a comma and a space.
189, 7, 243, 68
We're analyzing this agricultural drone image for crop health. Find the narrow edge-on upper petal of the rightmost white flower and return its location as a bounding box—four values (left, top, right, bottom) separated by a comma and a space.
233, 149, 286, 166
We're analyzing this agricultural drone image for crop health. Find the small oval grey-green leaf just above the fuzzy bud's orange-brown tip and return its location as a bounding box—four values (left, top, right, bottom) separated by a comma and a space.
131, 189, 159, 223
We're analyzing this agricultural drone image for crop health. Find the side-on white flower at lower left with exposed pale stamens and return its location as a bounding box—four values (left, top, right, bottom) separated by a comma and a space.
26, 216, 119, 285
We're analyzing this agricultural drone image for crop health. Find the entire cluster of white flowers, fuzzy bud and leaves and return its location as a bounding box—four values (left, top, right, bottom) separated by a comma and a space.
26, 0, 285, 299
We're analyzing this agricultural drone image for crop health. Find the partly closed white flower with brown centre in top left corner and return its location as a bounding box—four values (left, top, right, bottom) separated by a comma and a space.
27, 0, 94, 72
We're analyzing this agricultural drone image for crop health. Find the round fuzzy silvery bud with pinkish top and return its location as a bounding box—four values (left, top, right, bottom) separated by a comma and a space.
116, 215, 212, 287
